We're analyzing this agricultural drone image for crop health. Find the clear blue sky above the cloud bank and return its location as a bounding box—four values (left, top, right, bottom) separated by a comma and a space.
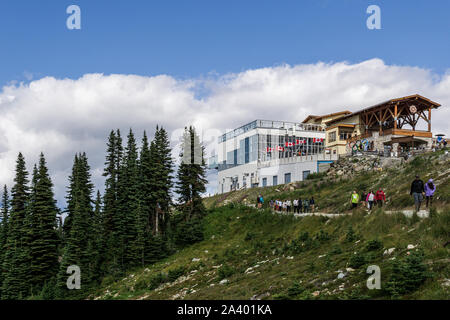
0, 0, 450, 86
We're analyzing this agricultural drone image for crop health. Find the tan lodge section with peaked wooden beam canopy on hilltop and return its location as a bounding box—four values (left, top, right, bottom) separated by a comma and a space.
305, 94, 441, 155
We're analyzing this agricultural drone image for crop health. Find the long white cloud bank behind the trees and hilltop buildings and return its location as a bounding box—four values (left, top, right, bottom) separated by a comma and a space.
0, 59, 450, 204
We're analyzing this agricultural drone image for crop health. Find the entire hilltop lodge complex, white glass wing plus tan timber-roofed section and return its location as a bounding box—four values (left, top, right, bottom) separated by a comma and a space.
210, 94, 441, 193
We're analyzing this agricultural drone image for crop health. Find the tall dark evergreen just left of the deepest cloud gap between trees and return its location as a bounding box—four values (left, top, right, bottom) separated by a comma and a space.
30, 153, 58, 292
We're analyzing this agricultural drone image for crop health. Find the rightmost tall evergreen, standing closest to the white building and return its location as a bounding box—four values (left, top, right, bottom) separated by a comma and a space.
175, 126, 207, 244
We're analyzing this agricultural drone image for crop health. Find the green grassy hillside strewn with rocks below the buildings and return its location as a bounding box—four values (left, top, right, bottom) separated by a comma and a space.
90, 153, 450, 299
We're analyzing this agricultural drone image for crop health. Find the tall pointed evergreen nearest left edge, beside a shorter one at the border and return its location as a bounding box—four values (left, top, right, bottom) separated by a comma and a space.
2, 153, 30, 299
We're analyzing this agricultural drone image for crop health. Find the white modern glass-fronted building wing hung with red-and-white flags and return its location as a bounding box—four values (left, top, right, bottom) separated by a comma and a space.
214, 120, 337, 193
